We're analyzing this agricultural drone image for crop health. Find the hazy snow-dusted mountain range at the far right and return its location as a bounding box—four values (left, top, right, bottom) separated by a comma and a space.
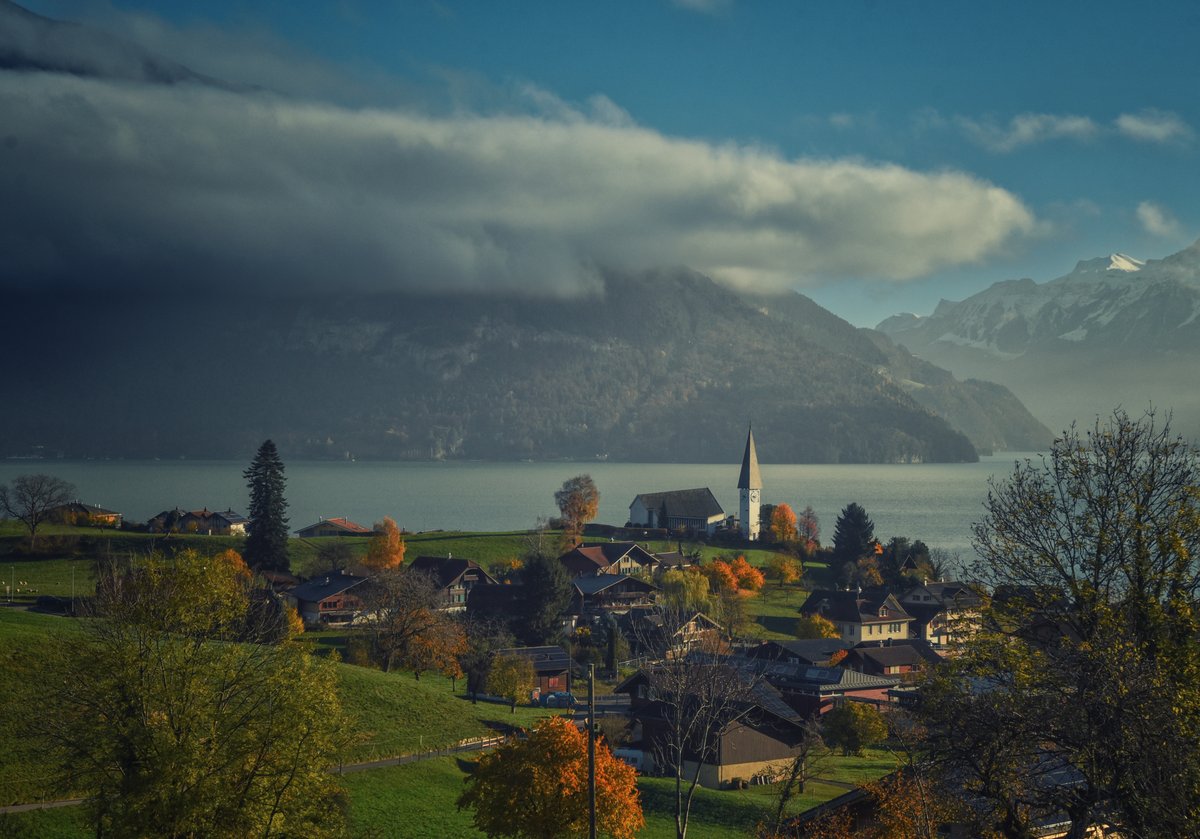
877, 236, 1200, 437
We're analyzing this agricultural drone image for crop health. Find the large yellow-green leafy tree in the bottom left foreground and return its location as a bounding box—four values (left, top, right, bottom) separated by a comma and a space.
30, 555, 344, 838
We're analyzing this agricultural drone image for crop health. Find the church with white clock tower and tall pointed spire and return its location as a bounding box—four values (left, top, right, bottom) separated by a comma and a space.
629, 429, 762, 540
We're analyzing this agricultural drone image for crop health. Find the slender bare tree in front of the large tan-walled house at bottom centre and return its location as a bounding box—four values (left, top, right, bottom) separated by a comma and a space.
634, 607, 761, 839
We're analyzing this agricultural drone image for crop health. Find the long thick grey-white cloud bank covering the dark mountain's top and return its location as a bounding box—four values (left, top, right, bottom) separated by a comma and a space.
0, 73, 1034, 294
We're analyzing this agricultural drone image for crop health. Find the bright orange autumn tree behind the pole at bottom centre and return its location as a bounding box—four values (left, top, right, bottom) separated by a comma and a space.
458, 717, 646, 839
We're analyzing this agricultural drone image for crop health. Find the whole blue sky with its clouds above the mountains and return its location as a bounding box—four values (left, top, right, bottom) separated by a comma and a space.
0, 0, 1200, 326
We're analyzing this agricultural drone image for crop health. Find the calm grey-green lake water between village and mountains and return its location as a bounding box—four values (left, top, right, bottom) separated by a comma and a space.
0, 453, 1041, 557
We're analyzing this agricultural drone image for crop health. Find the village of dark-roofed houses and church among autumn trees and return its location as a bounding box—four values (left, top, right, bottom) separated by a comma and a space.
4, 430, 998, 835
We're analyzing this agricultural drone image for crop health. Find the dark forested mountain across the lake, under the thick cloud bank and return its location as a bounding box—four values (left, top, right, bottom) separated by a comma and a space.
0, 269, 1044, 462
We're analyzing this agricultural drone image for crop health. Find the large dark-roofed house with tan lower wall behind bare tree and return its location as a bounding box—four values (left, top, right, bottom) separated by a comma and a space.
616, 661, 804, 789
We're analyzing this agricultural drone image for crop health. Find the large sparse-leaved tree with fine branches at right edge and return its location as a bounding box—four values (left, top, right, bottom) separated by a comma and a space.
922, 410, 1200, 839
